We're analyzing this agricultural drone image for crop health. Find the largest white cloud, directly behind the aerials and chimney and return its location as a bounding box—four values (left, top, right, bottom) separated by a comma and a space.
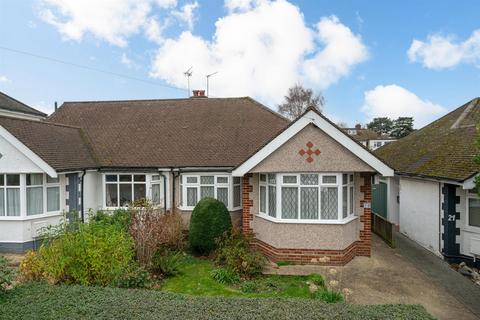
151, 0, 368, 104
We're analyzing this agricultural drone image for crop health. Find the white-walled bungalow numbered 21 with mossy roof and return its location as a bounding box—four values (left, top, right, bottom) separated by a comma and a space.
375, 98, 480, 266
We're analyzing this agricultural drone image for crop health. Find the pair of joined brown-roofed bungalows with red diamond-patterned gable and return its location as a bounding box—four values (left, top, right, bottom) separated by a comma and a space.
0, 90, 394, 265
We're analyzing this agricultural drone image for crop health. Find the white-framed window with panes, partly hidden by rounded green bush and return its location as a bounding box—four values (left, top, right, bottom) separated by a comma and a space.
181, 174, 241, 210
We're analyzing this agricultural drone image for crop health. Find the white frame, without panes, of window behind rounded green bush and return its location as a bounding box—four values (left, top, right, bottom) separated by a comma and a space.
180, 172, 242, 211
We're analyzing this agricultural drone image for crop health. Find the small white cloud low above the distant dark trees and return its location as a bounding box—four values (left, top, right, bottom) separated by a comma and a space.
362, 84, 447, 128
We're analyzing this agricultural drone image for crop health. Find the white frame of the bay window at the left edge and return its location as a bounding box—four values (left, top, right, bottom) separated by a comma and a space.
0, 172, 65, 221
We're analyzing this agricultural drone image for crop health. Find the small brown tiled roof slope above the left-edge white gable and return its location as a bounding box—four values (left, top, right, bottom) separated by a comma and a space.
0, 117, 96, 170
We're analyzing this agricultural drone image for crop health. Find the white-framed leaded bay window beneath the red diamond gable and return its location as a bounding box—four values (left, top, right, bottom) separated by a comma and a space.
259, 173, 355, 222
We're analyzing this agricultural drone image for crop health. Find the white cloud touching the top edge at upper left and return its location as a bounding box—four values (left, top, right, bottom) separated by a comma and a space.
39, 0, 186, 47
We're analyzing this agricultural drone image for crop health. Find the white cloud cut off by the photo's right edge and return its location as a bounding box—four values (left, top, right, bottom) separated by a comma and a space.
407, 29, 480, 70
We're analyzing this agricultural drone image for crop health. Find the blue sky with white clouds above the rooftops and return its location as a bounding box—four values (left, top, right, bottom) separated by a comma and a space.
0, 0, 480, 128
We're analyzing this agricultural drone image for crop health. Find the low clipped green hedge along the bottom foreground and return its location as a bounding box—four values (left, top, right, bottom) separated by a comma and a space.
0, 283, 433, 320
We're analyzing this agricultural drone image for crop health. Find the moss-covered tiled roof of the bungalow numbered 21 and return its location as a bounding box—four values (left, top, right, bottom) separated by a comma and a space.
374, 98, 480, 181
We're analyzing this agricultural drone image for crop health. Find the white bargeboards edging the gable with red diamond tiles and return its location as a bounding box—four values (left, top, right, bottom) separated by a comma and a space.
232, 111, 394, 177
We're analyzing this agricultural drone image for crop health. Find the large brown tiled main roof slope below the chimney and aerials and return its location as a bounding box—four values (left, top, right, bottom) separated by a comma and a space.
49, 97, 289, 168
